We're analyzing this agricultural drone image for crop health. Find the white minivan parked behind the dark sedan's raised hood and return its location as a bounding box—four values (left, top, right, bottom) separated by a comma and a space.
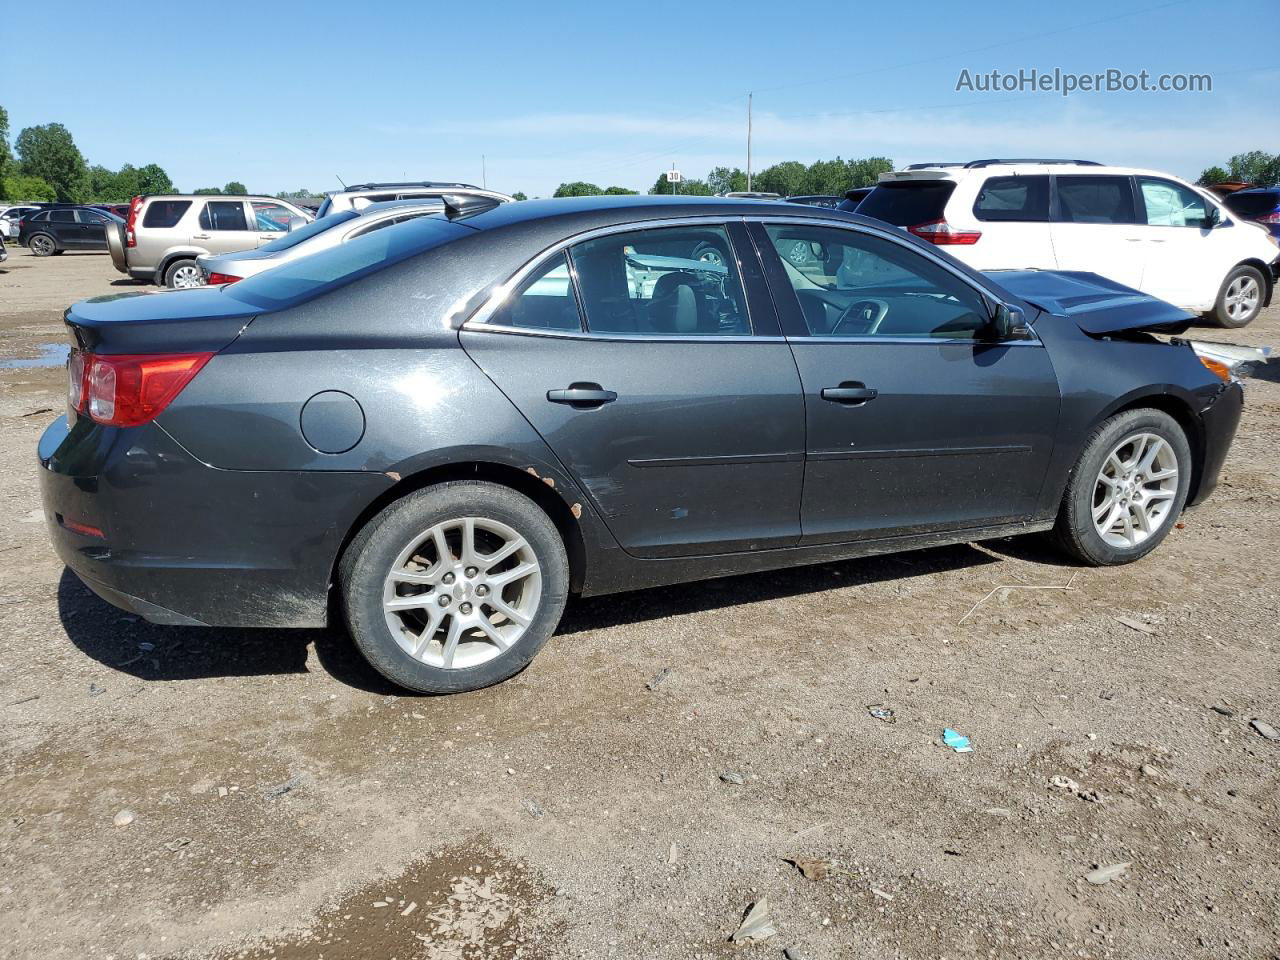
858, 160, 1280, 326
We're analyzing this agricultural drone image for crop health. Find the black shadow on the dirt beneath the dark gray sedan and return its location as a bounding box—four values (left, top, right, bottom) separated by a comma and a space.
58, 538, 1018, 695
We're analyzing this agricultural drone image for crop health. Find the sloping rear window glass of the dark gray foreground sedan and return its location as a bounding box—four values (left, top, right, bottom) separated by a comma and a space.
224, 216, 471, 310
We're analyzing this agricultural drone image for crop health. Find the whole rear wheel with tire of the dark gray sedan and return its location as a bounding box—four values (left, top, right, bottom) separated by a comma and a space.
338, 480, 568, 694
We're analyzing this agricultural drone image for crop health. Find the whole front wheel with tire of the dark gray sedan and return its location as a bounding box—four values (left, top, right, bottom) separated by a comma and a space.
1053, 410, 1192, 567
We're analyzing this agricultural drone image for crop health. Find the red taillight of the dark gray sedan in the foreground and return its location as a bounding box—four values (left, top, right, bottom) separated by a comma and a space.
68, 349, 214, 426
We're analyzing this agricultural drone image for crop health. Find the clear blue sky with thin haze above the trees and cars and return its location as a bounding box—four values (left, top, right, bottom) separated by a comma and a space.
0, 0, 1280, 196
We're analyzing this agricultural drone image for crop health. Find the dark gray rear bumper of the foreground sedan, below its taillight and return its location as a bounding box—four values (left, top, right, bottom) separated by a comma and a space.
38, 417, 392, 627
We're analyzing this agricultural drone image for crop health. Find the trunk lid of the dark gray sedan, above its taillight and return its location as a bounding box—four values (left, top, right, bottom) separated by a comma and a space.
64, 287, 262, 353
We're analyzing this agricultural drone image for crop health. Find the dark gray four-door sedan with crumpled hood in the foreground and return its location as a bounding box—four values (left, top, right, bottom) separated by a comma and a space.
38, 197, 1242, 692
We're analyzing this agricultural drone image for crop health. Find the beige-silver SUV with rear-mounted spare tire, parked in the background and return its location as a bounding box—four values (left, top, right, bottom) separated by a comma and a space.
106, 193, 312, 287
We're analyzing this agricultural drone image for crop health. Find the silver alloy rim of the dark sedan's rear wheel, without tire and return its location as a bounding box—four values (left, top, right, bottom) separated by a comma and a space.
383, 517, 541, 669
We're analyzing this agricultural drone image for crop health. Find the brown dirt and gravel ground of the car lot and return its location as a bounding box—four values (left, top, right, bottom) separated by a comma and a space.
0, 250, 1280, 960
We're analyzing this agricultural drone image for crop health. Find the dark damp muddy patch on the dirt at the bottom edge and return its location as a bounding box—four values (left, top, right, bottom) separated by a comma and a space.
199, 842, 563, 960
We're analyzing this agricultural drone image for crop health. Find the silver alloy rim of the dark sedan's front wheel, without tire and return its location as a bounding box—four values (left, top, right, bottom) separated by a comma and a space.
1093, 433, 1178, 549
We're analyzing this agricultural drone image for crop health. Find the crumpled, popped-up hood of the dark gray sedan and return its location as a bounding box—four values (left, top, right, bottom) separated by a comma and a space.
986, 270, 1196, 335
